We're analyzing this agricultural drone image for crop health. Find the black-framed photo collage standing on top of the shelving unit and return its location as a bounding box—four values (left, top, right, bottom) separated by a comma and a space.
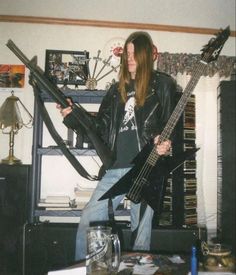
45, 49, 89, 86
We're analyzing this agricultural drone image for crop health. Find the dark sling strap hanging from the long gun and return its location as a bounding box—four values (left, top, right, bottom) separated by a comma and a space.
31, 85, 98, 181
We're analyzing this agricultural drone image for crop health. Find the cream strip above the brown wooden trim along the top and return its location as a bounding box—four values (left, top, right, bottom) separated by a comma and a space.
0, 0, 235, 30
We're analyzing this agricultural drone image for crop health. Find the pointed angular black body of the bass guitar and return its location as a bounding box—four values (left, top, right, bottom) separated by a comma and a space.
99, 143, 198, 212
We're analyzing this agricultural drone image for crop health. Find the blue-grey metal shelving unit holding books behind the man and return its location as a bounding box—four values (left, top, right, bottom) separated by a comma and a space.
29, 86, 107, 223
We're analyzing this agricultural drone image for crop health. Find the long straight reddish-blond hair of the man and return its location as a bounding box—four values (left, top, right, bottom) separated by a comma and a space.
119, 31, 153, 106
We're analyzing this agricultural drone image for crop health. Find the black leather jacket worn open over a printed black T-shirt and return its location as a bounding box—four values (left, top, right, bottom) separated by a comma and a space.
95, 71, 177, 157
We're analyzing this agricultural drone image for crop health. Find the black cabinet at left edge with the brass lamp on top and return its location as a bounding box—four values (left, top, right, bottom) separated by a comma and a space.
0, 164, 30, 275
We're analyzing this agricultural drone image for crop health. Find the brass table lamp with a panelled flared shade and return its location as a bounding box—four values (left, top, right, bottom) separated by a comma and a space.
0, 91, 33, 165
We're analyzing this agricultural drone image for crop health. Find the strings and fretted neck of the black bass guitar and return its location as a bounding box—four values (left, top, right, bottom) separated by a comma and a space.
128, 62, 206, 203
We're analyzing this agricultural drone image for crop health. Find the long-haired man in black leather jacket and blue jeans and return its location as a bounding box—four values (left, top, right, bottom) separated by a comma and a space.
57, 31, 176, 260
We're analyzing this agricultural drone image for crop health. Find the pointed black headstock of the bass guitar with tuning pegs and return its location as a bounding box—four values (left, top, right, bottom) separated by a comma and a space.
201, 26, 230, 63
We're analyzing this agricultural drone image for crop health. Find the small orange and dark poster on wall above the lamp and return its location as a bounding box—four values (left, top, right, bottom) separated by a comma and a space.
0, 64, 25, 88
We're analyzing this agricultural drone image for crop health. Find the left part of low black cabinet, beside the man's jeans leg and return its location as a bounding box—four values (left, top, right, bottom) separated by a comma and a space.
22, 223, 78, 275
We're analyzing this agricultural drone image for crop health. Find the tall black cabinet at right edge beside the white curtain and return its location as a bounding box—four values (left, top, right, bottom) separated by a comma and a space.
217, 80, 236, 255
